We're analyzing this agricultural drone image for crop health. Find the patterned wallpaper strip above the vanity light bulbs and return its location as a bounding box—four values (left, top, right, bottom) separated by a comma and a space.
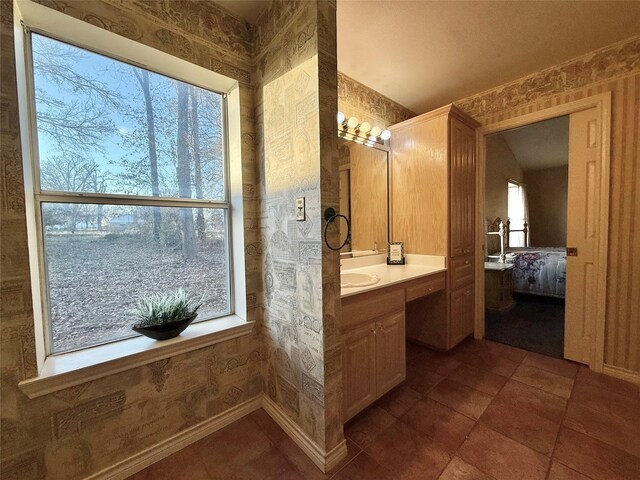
338, 72, 416, 128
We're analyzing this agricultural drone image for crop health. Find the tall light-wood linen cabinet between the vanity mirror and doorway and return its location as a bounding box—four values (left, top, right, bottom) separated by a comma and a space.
390, 105, 478, 350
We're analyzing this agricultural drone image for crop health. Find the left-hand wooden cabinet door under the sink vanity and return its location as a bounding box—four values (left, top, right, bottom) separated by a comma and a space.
342, 323, 377, 422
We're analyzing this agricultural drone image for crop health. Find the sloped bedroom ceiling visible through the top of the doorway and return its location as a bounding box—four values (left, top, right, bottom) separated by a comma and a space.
496, 115, 569, 171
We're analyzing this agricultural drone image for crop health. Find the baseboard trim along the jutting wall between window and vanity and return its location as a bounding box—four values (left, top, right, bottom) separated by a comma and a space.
262, 395, 347, 473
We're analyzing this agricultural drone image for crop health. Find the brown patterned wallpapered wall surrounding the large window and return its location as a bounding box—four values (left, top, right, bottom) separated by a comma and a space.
0, 0, 264, 480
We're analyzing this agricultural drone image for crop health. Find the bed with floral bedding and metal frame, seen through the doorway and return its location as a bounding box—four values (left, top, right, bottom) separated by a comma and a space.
487, 218, 567, 298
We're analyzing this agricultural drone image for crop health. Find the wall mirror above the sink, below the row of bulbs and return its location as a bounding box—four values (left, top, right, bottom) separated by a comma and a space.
338, 139, 390, 256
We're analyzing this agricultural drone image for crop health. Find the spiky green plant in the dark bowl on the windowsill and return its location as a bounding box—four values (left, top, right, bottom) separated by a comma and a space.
133, 288, 204, 327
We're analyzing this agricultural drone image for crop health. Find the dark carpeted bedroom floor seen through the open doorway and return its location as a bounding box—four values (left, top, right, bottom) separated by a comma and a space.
485, 294, 564, 358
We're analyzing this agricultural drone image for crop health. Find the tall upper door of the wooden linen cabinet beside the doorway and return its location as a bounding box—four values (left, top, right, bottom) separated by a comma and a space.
449, 118, 476, 257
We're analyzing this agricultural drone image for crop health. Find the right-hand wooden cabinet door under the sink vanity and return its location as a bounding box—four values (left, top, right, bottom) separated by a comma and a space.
376, 310, 407, 397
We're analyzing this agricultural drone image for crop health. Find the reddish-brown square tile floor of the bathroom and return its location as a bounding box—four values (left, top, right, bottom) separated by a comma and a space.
130, 339, 640, 480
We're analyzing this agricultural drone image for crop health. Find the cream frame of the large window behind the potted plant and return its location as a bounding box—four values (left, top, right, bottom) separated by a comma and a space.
14, 0, 248, 382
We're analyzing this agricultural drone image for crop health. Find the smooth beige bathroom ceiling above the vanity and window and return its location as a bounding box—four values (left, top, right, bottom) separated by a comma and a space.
220, 0, 640, 113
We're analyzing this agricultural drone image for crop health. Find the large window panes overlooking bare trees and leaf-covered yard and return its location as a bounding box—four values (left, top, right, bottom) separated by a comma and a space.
30, 33, 233, 354
